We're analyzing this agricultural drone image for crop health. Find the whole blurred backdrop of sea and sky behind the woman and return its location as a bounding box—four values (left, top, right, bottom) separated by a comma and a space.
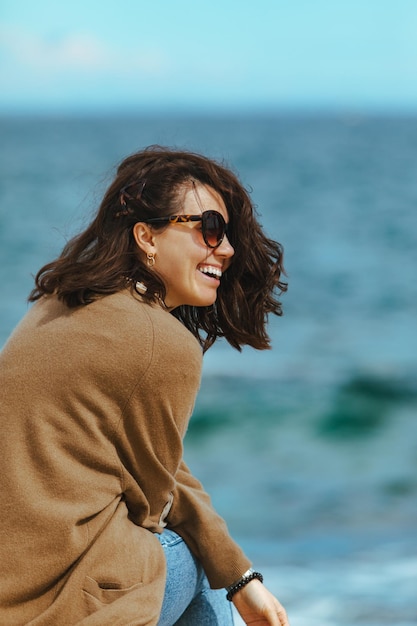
0, 0, 417, 626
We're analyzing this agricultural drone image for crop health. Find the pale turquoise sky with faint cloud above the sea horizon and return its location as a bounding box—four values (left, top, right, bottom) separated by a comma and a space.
0, 0, 417, 113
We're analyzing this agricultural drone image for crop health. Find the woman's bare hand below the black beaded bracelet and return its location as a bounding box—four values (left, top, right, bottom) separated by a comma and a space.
232, 579, 290, 626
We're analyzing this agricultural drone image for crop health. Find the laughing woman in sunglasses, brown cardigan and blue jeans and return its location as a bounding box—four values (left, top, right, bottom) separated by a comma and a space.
0, 147, 288, 626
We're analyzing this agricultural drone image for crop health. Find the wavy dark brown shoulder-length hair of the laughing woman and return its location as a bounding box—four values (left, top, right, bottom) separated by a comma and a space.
29, 146, 287, 350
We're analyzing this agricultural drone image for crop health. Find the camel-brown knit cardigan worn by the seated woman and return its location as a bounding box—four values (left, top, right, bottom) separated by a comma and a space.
0, 290, 250, 626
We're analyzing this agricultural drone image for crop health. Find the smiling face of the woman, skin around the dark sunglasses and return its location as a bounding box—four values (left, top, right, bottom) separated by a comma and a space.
139, 185, 234, 310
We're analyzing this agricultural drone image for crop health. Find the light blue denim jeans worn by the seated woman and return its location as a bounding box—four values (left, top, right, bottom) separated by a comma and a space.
156, 529, 233, 626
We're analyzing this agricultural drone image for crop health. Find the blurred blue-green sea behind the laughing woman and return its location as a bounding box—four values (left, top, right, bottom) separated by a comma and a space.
0, 112, 417, 626
